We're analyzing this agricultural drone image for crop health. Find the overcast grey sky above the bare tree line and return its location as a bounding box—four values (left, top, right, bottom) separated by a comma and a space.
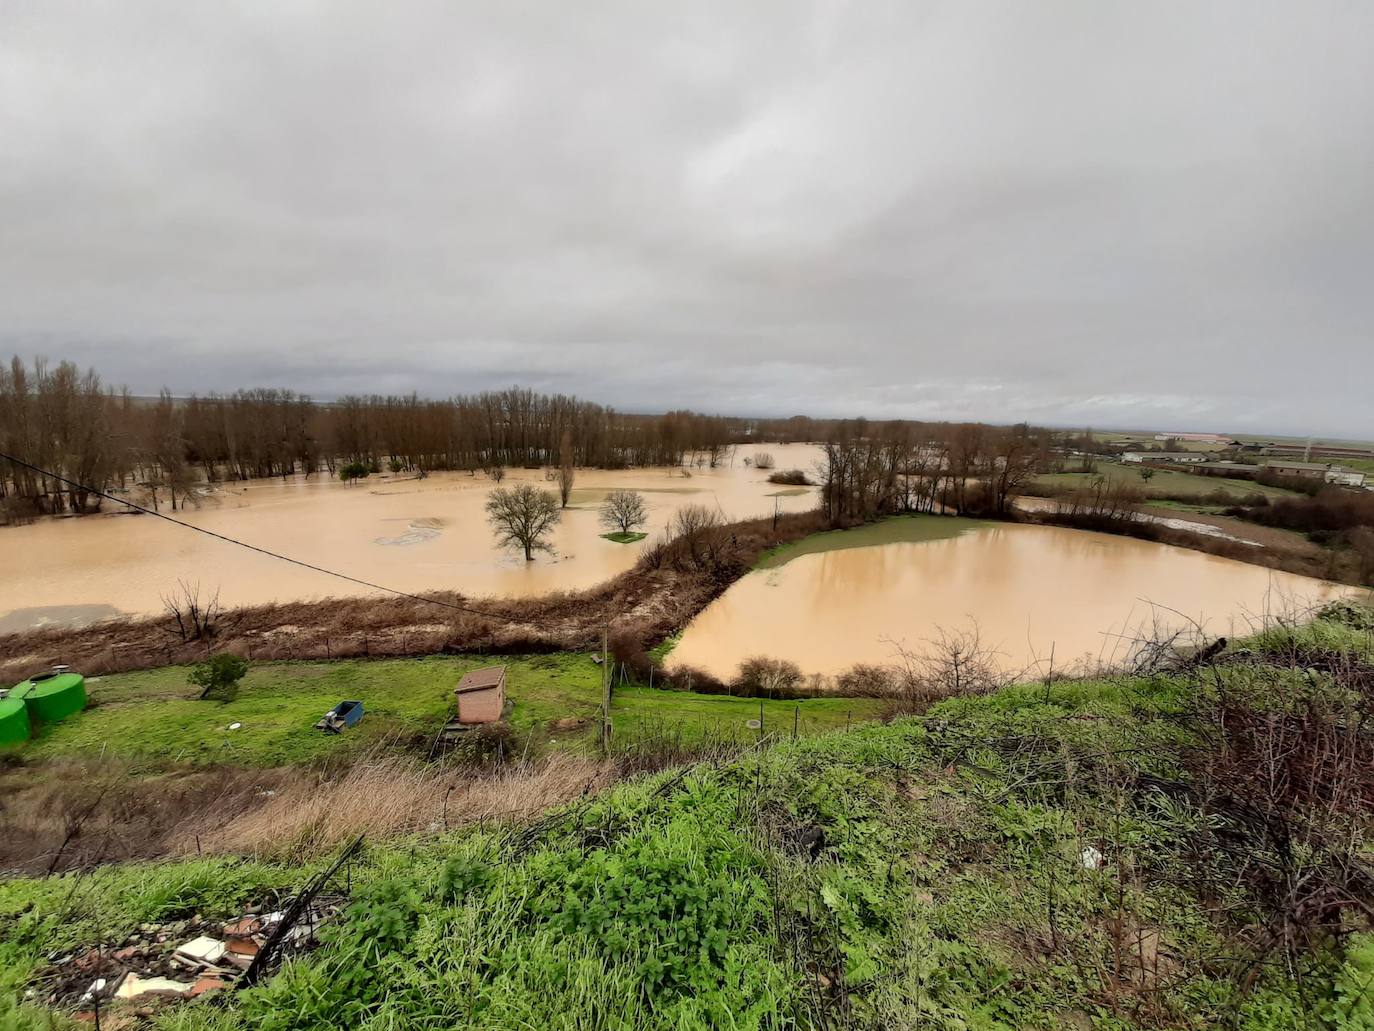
0, 0, 1374, 437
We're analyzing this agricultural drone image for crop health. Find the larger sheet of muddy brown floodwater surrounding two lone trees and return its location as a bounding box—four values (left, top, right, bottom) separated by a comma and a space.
0, 444, 820, 632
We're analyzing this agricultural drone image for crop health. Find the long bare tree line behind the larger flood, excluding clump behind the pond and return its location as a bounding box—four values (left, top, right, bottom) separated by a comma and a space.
0, 357, 747, 520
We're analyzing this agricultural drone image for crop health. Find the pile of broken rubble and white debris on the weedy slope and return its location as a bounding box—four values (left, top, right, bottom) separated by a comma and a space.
44, 895, 344, 1020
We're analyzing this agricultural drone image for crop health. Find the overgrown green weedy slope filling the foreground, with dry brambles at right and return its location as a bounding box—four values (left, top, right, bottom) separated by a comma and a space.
0, 609, 1374, 1031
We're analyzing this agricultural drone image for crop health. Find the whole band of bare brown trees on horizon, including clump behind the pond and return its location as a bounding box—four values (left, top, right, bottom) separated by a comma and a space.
0, 357, 1052, 525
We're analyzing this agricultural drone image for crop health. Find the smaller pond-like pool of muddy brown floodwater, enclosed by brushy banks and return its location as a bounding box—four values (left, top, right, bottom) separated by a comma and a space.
671, 525, 1363, 679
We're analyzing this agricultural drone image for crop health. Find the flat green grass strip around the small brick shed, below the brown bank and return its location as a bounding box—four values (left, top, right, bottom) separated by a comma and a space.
23, 653, 881, 766
